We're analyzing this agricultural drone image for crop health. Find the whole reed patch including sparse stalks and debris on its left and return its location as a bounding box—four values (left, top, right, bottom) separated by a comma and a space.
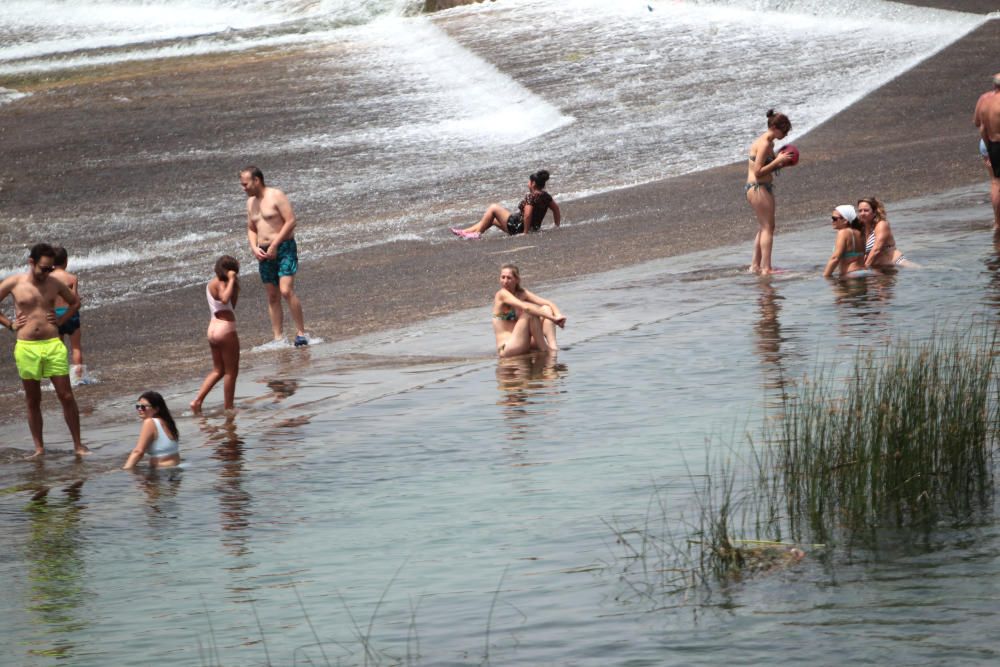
614, 329, 1000, 604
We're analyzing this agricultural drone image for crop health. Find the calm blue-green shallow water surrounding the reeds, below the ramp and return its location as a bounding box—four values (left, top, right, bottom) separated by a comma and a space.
0, 188, 1000, 665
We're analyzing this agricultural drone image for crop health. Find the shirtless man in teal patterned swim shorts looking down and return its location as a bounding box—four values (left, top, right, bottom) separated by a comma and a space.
240, 166, 309, 347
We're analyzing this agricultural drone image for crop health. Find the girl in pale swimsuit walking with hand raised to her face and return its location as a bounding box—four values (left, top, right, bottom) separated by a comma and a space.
191, 255, 240, 412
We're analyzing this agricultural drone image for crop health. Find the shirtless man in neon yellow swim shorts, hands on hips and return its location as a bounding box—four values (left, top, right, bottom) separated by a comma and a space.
0, 243, 90, 458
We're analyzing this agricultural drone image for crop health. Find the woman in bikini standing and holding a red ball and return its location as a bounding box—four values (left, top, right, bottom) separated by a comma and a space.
744, 109, 797, 275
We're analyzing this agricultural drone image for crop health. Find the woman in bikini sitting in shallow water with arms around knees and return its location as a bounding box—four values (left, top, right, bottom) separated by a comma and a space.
493, 264, 566, 358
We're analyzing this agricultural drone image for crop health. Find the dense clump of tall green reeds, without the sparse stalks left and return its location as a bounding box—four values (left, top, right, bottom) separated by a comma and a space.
765, 333, 1000, 543
